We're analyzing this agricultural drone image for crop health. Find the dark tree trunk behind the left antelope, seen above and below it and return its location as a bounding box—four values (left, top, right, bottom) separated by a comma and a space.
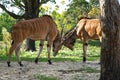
24, 0, 40, 51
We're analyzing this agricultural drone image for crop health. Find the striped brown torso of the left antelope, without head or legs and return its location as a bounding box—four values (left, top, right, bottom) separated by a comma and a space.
11, 15, 58, 41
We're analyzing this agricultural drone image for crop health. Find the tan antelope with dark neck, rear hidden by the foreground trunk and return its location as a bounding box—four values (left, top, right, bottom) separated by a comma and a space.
62, 18, 102, 62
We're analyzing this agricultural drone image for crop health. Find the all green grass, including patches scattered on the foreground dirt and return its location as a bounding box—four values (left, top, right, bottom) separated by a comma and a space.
0, 40, 100, 80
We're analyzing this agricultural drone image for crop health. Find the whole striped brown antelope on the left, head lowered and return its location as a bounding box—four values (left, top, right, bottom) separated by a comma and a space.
7, 15, 61, 66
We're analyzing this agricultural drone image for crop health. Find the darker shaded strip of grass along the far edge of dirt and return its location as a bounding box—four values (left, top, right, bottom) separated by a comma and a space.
0, 56, 99, 62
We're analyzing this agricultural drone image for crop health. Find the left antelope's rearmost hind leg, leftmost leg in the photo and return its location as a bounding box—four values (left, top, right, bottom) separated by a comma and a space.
7, 41, 18, 67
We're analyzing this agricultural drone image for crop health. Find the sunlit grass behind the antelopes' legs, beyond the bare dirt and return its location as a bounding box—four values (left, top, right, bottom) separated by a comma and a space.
0, 40, 100, 61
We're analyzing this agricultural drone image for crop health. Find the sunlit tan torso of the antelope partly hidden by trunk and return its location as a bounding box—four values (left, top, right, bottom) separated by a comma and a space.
77, 19, 101, 39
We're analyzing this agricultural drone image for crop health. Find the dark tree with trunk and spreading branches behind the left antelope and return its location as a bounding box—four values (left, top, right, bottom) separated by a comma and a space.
0, 0, 55, 51
